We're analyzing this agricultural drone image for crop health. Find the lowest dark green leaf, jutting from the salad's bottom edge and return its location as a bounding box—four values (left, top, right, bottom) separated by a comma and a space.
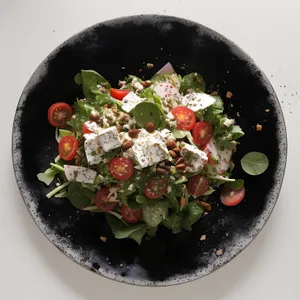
105, 214, 147, 245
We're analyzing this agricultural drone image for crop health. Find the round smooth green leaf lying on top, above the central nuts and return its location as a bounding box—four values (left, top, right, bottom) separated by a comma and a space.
133, 102, 161, 127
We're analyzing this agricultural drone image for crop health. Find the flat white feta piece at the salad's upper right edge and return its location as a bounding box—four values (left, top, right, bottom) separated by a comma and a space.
182, 93, 216, 111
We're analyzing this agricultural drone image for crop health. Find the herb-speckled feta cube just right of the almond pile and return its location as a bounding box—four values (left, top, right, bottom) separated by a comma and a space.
181, 143, 208, 172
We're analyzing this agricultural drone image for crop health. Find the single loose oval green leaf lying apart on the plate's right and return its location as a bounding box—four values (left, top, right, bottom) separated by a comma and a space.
241, 152, 269, 175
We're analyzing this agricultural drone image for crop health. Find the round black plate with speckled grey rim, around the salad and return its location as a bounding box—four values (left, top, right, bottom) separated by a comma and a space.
12, 15, 287, 286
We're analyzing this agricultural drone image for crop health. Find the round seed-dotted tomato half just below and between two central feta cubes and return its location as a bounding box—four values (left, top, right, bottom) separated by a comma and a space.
109, 157, 134, 181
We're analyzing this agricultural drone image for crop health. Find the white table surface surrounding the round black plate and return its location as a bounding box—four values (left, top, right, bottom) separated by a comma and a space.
0, 0, 300, 300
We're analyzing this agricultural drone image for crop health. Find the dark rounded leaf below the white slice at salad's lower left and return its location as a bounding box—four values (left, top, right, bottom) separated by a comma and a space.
68, 182, 94, 209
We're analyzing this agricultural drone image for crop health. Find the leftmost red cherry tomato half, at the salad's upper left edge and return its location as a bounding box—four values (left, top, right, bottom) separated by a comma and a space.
48, 102, 72, 127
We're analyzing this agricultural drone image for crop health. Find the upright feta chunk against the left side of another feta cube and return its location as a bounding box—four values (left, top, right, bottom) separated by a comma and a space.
84, 133, 104, 165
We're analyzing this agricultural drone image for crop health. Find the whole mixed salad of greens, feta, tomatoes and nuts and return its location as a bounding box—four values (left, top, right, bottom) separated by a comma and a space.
37, 63, 266, 244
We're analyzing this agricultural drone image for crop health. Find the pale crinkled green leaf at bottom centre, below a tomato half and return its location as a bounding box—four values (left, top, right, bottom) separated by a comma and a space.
143, 200, 168, 227
